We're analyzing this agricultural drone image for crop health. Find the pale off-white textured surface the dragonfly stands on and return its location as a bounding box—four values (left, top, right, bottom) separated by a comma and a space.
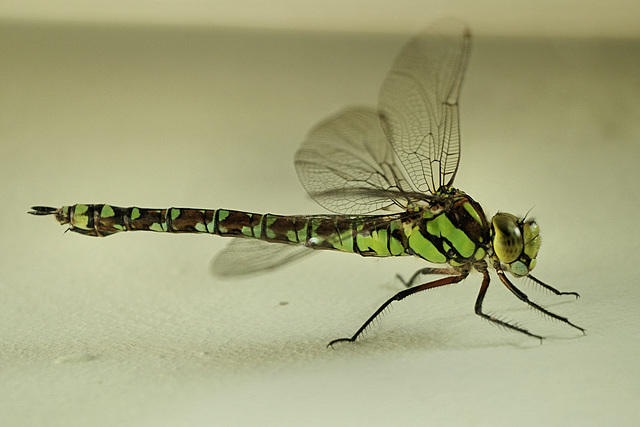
0, 22, 640, 426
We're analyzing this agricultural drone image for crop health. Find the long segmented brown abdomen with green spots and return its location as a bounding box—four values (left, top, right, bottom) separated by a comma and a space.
55, 204, 407, 256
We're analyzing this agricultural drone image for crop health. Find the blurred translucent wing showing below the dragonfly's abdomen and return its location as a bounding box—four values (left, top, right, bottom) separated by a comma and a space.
212, 238, 314, 276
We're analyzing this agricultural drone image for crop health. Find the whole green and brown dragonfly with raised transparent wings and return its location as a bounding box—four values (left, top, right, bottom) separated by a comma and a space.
29, 21, 585, 346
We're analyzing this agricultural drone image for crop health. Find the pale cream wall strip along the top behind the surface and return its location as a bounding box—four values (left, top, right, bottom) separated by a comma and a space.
0, 0, 640, 36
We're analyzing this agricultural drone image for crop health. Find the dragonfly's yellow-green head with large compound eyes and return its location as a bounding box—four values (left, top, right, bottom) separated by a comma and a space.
491, 212, 540, 276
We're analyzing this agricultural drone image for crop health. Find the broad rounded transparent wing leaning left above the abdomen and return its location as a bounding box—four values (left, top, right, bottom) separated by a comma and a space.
295, 107, 411, 214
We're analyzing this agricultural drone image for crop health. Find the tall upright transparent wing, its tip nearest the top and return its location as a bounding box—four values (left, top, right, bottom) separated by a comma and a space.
378, 20, 471, 194
